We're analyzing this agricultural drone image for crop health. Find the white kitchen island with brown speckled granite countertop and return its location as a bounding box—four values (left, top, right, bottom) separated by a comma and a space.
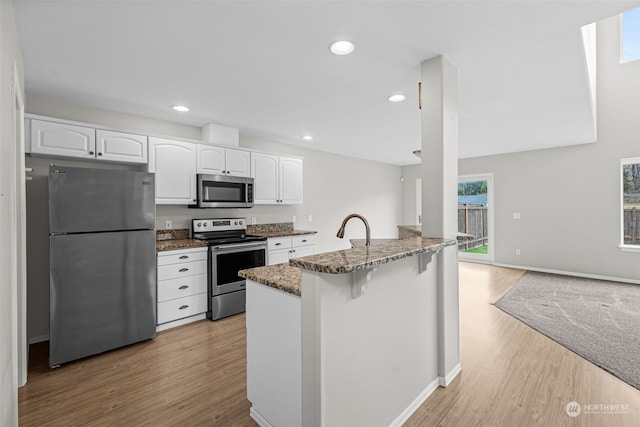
240, 237, 459, 427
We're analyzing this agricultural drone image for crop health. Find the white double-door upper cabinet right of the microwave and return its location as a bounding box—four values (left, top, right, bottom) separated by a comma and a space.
251, 152, 303, 205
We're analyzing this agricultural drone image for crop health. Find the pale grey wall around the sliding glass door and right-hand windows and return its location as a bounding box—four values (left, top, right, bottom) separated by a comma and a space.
402, 17, 640, 281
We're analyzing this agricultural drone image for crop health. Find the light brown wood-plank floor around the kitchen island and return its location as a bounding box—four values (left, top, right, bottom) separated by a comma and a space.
19, 263, 640, 427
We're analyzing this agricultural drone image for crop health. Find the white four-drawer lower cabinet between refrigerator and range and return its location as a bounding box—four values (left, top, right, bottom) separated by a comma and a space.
156, 247, 207, 330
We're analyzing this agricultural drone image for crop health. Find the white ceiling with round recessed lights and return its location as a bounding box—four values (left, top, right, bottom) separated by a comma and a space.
14, 0, 640, 165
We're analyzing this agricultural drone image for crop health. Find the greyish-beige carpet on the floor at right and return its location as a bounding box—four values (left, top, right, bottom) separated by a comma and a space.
495, 272, 640, 390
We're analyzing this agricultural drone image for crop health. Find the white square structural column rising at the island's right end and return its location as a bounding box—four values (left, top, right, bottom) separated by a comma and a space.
421, 56, 460, 386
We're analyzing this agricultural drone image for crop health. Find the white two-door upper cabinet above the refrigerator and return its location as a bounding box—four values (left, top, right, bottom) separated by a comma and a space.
29, 119, 147, 164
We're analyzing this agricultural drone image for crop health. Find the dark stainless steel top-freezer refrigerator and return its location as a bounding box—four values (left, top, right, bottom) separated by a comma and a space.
49, 165, 156, 367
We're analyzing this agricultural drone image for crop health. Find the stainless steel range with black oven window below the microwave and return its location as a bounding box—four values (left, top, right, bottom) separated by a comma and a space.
192, 218, 267, 320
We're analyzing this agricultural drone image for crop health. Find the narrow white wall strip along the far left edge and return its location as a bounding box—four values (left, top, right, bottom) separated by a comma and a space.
0, 1, 24, 426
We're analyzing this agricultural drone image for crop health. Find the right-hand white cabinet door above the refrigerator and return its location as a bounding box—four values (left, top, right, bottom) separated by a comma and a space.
96, 129, 147, 164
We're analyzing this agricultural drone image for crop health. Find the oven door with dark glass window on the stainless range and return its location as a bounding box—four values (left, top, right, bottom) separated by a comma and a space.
209, 242, 267, 296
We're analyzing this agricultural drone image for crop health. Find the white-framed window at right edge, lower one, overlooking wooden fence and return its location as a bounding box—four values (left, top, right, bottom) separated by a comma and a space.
620, 157, 640, 250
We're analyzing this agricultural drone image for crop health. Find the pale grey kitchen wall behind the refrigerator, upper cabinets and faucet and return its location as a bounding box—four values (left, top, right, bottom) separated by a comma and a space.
26, 97, 402, 340
